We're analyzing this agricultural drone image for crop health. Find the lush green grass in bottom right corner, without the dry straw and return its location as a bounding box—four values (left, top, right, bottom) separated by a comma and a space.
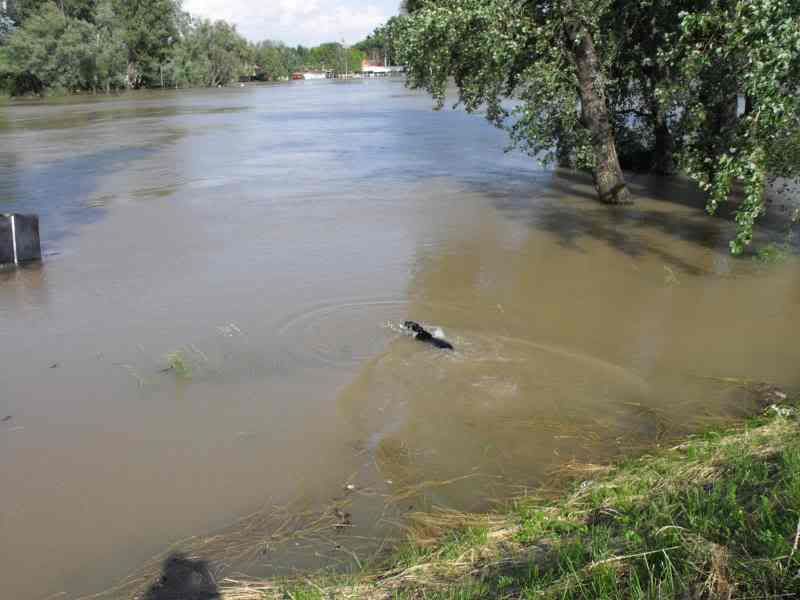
507, 426, 800, 599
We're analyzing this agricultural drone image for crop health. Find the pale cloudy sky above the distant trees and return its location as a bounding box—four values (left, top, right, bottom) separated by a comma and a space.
183, 0, 400, 46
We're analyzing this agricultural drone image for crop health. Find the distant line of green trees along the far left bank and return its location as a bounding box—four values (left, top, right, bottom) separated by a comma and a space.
0, 0, 365, 95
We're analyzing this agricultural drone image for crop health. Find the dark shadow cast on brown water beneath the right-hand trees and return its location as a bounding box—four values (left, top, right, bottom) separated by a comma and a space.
478, 170, 800, 275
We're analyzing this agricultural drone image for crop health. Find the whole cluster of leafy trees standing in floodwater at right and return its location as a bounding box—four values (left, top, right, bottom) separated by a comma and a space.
385, 0, 800, 253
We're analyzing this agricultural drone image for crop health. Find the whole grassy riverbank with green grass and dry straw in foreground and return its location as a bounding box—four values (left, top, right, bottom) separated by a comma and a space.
221, 391, 800, 600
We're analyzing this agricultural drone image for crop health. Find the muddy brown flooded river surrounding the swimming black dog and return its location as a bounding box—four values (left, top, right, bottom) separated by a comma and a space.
0, 81, 800, 600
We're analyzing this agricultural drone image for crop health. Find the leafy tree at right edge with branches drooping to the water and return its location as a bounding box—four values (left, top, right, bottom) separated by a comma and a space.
660, 0, 800, 253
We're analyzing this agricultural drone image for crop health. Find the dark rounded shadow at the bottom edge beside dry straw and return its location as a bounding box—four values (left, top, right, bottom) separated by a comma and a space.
144, 554, 221, 600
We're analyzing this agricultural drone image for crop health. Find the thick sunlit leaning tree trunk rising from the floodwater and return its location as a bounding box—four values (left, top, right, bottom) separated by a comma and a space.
564, 9, 632, 204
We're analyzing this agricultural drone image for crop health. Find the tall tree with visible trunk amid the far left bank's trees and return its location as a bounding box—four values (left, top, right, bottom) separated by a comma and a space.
114, 0, 180, 88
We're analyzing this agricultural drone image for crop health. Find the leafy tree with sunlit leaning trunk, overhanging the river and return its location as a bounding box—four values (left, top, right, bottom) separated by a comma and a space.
389, 0, 630, 204
